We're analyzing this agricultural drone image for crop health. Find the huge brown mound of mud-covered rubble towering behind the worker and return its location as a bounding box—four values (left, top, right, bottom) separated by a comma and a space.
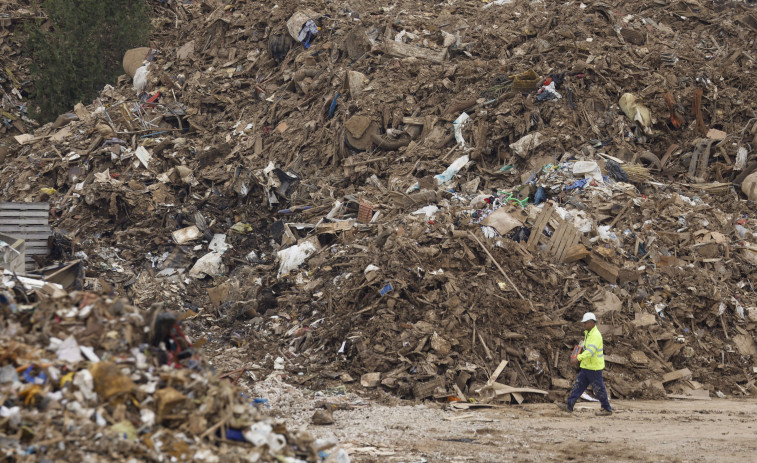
0, 0, 757, 410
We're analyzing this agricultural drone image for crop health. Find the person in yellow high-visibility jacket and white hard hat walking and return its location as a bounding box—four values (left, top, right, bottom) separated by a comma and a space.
562, 312, 612, 416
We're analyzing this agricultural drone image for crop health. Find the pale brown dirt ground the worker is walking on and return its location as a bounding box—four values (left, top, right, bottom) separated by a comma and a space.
241, 381, 757, 463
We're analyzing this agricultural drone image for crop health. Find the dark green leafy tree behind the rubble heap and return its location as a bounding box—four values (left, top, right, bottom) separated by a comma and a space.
25, 0, 150, 122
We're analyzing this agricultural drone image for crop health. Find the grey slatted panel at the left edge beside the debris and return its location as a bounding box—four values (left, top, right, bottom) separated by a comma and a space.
0, 203, 51, 270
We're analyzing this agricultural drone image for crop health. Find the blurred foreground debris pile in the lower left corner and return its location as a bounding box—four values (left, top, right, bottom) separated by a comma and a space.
0, 272, 343, 462
